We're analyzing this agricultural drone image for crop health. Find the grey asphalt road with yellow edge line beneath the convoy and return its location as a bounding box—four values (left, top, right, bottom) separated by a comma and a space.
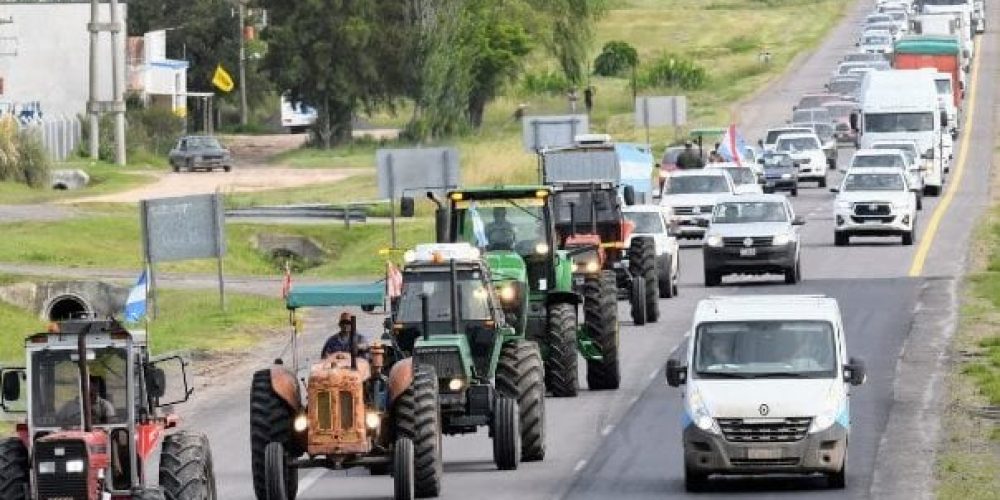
182, 1, 1000, 500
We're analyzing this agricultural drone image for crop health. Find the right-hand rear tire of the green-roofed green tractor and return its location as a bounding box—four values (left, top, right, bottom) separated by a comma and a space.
583, 271, 621, 391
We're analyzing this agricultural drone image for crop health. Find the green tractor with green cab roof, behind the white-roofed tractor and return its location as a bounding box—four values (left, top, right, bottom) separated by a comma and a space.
406, 186, 621, 397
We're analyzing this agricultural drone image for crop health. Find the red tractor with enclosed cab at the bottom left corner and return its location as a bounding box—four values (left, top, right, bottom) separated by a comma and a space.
0, 319, 216, 500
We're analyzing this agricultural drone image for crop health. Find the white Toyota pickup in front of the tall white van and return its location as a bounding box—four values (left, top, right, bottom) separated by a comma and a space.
831, 168, 917, 246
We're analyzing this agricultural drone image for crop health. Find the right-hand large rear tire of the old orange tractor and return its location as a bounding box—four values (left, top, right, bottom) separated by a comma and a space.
393, 365, 444, 498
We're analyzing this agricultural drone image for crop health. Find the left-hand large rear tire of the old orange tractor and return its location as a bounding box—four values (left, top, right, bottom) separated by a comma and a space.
250, 369, 303, 500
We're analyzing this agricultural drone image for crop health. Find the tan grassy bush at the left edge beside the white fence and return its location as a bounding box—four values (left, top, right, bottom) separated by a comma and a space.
0, 115, 51, 187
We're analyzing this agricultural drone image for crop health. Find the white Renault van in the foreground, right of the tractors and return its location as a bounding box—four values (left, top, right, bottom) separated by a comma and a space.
666, 295, 865, 491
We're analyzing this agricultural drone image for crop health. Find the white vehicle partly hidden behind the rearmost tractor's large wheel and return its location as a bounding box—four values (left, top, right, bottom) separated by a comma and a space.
622, 205, 681, 299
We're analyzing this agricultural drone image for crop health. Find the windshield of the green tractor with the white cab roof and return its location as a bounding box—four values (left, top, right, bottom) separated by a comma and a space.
397, 270, 490, 323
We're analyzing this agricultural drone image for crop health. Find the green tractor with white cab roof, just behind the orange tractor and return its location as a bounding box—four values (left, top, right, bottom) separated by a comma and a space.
388, 243, 545, 464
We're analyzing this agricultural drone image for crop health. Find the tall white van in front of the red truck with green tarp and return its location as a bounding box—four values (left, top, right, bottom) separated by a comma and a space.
859, 69, 951, 196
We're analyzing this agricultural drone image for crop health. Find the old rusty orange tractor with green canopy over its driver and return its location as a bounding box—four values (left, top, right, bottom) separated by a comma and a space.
250, 284, 442, 500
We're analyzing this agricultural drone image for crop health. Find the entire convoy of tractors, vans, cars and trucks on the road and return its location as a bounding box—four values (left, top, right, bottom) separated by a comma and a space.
0, 0, 985, 500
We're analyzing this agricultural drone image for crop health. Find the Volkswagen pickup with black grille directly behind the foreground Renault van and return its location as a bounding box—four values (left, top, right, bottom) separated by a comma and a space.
702, 194, 805, 286
